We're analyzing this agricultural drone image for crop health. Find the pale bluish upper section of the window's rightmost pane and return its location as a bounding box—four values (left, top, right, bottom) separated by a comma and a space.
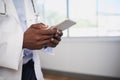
98, 0, 120, 15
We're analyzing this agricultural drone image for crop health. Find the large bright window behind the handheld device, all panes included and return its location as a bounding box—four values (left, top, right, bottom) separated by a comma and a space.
37, 0, 120, 37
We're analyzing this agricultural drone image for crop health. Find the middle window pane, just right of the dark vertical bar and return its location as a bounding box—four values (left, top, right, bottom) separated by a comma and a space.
69, 0, 97, 37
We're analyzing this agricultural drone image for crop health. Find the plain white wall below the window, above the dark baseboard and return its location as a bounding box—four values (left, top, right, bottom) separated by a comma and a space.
40, 38, 120, 78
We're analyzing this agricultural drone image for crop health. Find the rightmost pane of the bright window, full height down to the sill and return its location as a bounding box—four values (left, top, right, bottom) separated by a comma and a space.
98, 0, 120, 36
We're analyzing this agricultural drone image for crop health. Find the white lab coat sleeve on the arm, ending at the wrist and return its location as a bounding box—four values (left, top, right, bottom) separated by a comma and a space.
0, 14, 23, 70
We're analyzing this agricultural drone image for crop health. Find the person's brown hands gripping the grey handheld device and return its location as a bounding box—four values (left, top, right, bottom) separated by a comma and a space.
23, 23, 63, 50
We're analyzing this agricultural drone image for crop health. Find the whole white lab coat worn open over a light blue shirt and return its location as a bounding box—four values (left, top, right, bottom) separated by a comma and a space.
0, 0, 43, 80
